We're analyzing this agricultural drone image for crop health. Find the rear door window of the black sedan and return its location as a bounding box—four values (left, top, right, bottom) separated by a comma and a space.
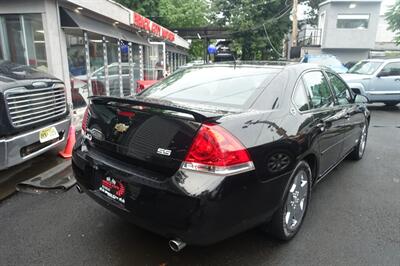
303, 71, 334, 109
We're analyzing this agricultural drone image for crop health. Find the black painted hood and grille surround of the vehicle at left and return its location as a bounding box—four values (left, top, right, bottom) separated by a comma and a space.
0, 61, 69, 137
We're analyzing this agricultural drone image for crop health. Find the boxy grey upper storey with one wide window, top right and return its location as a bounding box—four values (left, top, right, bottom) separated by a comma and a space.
318, 0, 381, 62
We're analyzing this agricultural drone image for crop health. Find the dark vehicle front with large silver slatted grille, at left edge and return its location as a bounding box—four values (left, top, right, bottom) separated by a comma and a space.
0, 61, 71, 170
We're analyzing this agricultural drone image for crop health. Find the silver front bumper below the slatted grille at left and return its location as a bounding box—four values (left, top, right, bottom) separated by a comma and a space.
0, 117, 71, 170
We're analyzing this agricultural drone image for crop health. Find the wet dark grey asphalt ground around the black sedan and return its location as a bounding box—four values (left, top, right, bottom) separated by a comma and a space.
0, 106, 400, 266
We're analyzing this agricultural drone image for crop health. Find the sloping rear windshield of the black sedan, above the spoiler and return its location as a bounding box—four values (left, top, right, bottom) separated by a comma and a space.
139, 66, 280, 107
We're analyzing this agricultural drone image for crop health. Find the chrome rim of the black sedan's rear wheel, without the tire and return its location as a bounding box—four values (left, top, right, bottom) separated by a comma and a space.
283, 170, 309, 231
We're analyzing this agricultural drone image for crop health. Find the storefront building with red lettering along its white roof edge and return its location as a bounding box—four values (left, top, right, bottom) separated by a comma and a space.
0, 0, 189, 113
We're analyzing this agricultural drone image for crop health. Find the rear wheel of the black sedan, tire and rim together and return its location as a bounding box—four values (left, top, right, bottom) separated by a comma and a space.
266, 161, 312, 241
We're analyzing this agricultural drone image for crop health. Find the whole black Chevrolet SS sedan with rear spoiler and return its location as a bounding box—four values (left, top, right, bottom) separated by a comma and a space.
72, 63, 370, 251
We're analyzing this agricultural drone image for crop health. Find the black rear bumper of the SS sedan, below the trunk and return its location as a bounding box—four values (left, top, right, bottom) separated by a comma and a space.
72, 140, 290, 245
